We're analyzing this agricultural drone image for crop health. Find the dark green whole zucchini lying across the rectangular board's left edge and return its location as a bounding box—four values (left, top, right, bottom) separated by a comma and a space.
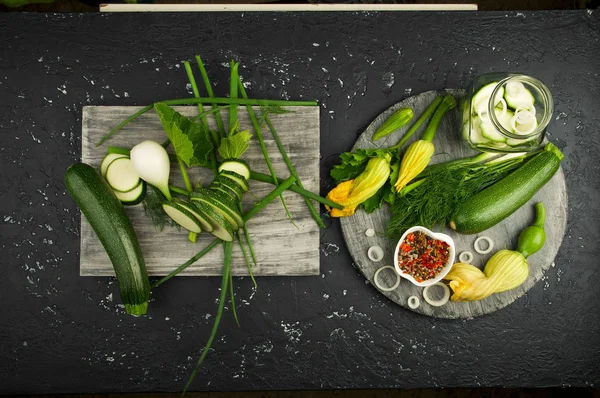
65, 163, 150, 316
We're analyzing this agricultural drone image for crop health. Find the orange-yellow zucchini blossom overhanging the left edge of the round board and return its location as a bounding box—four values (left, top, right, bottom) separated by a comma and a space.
326, 153, 392, 217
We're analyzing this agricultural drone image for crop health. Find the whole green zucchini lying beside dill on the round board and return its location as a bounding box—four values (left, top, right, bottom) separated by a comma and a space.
450, 143, 564, 234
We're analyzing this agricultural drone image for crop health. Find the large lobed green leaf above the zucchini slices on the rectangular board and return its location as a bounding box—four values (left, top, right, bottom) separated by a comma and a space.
154, 102, 213, 167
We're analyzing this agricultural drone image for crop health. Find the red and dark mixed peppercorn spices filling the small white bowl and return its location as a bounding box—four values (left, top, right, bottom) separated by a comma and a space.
398, 231, 450, 282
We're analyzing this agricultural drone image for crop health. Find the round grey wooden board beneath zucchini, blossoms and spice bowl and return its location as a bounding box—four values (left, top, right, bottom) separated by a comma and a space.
340, 90, 567, 318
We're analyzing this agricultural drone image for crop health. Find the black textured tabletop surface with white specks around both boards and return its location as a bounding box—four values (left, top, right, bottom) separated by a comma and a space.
0, 11, 600, 394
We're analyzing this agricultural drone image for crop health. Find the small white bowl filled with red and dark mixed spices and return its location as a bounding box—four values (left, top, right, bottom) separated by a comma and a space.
394, 226, 455, 287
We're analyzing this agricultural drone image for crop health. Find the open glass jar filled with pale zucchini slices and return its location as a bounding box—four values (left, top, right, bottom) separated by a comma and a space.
462, 73, 554, 152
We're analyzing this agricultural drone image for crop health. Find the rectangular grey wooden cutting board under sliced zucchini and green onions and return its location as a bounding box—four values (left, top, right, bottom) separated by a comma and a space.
80, 106, 320, 276
